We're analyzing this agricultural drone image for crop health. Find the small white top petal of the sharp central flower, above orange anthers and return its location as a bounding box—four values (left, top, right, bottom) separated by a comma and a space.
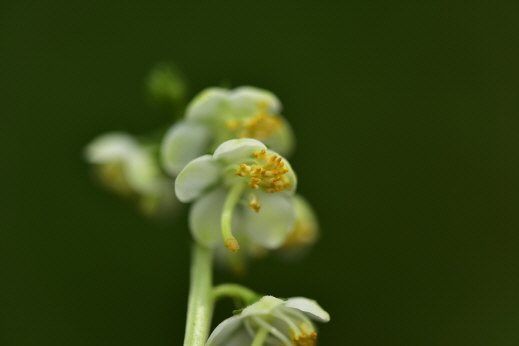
213, 138, 267, 165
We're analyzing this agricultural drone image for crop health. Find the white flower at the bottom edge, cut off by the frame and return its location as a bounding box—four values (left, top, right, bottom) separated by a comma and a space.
206, 296, 330, 346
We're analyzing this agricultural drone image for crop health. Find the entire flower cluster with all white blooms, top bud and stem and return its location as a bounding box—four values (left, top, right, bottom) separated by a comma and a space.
85, 75, 330, 346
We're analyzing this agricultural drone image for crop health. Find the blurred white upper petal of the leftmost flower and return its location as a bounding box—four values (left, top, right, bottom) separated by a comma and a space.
85, 132, 139, 163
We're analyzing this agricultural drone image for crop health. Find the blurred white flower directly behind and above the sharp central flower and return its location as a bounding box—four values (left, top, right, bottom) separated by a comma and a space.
161, 86, 294, 176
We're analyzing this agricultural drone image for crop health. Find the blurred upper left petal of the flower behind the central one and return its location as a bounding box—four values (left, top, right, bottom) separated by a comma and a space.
186, 88, 229, 124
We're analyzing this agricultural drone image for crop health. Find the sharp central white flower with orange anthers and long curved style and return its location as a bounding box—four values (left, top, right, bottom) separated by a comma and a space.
175, 138, 297, 252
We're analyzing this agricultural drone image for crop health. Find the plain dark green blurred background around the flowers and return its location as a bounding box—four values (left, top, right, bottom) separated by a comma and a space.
0, 1, 519, 346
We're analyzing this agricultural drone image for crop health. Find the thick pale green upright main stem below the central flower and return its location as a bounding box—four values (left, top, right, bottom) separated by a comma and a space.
184, 244, 213, 346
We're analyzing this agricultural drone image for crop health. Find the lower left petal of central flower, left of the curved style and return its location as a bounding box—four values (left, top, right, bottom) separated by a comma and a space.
189, 188, 227, 250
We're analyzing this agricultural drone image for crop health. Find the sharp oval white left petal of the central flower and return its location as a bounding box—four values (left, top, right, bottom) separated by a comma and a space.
175, 155, 221, 203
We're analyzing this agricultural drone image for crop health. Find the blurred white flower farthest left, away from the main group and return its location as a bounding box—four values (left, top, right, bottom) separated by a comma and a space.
85, 132, 179, 217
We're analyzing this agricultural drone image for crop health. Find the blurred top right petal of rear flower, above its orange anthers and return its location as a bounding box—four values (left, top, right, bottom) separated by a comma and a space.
229, 86, 281, 116
